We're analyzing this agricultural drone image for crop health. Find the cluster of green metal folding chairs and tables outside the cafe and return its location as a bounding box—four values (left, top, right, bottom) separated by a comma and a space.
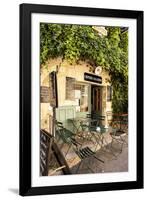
56, 113, 128, 173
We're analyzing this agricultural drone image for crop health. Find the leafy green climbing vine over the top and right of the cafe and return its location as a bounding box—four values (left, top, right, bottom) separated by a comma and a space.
40, 23, 128, 112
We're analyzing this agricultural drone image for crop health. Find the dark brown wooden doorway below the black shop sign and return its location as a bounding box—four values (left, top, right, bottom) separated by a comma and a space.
91, 85, 102, 114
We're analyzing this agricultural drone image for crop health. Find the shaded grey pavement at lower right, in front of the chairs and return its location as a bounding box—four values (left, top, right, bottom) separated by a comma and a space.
72, 138, 128, 174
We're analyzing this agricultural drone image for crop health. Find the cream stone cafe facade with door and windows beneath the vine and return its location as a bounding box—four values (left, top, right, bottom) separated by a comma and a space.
40, 58, 112, 132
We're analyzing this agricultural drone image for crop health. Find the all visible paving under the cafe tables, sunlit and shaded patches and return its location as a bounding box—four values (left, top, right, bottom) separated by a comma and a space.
49, 134, 128, 175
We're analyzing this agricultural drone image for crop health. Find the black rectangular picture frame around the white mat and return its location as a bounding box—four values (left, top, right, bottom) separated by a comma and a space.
19, 4, 143, 196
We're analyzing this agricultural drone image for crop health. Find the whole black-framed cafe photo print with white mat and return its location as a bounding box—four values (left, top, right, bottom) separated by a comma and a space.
20, 4, 143, 196
